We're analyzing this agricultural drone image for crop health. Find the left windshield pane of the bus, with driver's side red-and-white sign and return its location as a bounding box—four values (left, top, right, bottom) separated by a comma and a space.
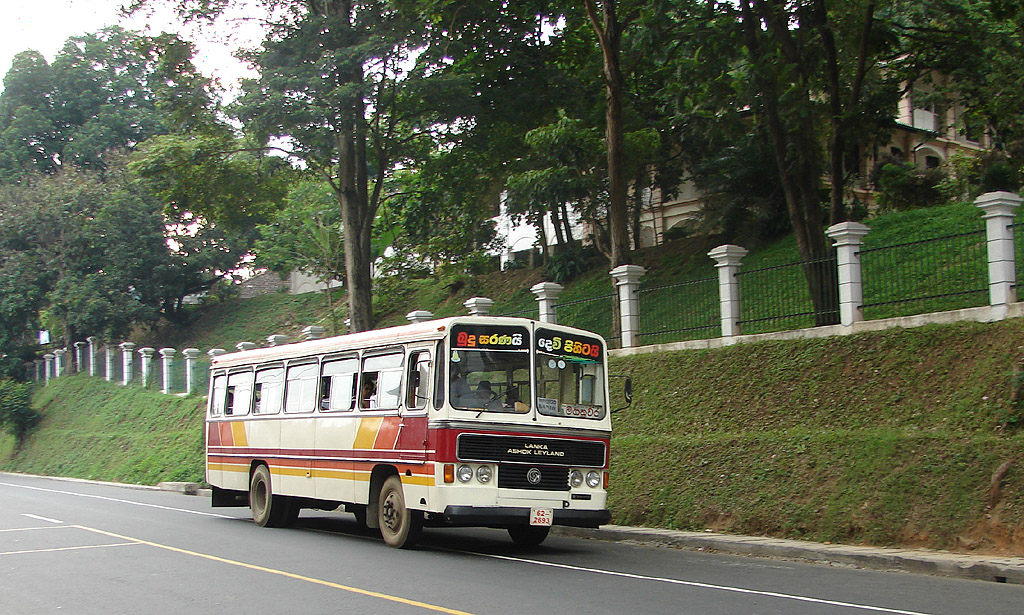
449, 325, 530, 413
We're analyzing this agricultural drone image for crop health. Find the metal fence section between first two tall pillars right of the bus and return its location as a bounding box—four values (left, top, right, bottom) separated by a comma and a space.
639, 277, 721, 344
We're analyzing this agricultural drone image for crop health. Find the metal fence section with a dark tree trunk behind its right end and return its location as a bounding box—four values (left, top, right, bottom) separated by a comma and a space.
736, 254, 839, 334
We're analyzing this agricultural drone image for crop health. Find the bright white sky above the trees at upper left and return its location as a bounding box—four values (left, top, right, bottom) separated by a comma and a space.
0, 0, 261, 96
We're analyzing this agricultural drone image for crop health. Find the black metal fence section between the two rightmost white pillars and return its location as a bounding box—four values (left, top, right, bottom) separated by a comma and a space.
860, 228, 988, 320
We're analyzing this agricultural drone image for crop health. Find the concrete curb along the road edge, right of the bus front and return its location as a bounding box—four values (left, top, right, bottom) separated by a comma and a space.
555, 525, 1024, 584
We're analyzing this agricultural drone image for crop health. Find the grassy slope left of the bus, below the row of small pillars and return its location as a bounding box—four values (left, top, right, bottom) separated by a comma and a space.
0, 376, 204, 485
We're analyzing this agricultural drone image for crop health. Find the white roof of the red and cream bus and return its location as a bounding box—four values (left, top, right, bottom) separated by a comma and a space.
211, 316, 604, 368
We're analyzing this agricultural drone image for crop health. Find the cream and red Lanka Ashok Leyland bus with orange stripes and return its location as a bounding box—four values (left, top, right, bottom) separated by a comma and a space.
198, 316, 611, 548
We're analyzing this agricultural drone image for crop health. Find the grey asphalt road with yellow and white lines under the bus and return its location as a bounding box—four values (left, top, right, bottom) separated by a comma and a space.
0, 474, 1024, 615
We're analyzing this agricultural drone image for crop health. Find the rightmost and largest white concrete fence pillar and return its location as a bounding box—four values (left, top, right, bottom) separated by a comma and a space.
974, 192, 1021, 305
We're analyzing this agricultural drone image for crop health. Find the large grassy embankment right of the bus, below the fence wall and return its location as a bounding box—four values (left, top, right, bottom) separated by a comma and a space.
610, 319, 1024, 555
